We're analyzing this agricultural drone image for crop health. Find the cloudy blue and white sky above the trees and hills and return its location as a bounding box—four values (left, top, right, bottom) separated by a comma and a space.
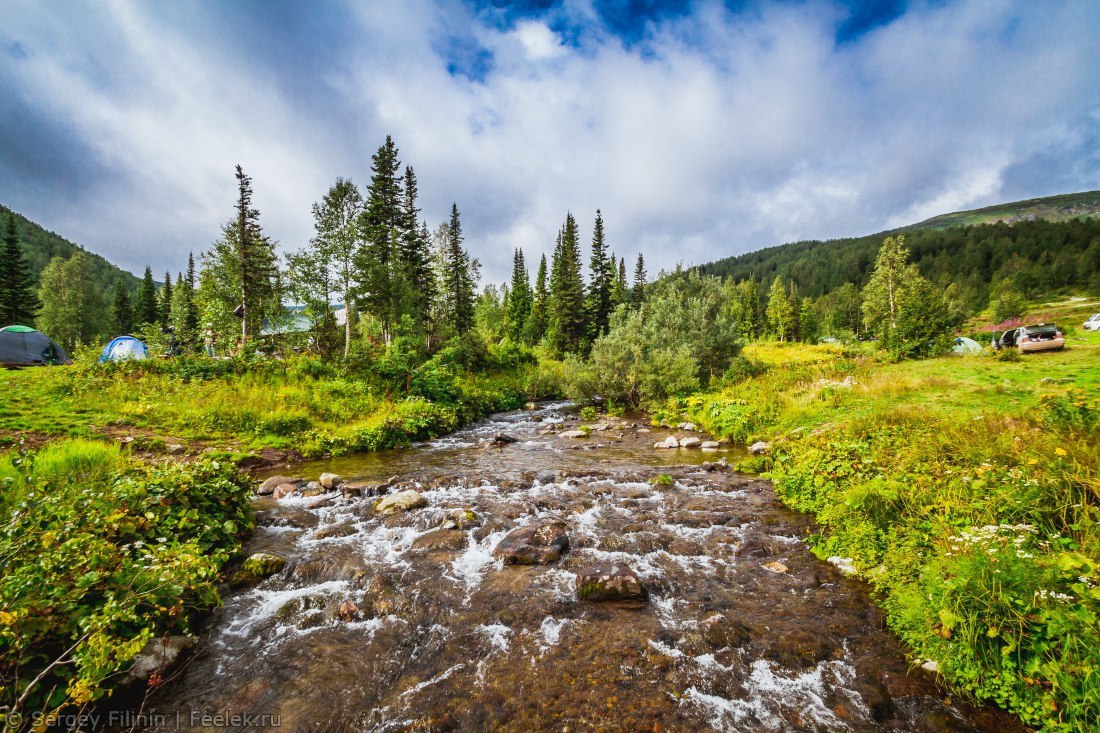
0, 0, 1100, 283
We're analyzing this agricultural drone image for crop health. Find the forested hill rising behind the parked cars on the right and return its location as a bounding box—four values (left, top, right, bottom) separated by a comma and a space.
699, 192, 1100, 305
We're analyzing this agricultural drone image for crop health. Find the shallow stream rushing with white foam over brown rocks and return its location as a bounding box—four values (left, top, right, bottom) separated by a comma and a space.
124, 405, 1021, 731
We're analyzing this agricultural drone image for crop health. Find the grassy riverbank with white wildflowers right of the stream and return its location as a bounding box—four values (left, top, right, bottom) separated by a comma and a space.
668, 333, 1100, 731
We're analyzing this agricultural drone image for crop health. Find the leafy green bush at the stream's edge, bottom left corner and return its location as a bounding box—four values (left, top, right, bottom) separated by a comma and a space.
0, 441, 252, 712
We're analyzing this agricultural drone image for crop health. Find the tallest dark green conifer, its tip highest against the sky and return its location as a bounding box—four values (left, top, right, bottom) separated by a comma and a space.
355, 135, 404, 343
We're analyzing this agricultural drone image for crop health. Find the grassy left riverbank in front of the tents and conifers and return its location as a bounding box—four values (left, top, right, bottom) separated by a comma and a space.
0, 350, 540, 457
